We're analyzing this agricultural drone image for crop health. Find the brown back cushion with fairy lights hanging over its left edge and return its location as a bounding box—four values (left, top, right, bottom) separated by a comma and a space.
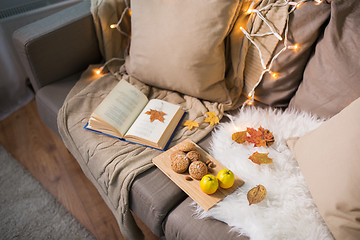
250, 1, 330, 107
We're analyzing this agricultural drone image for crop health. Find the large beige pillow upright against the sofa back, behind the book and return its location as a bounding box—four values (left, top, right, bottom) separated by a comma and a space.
126, 0, 241, 103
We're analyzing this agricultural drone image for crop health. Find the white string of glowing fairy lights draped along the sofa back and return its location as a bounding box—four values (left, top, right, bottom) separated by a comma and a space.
96, 0, 328, 106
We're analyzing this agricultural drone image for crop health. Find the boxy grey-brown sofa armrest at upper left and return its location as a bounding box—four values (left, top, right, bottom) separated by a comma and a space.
13, 0, 102, 91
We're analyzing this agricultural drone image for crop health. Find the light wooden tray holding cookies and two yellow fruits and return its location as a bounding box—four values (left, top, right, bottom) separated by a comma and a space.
152, 139, 244, 211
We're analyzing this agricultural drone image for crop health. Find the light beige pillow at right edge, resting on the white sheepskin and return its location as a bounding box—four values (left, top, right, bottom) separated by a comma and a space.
287, 98, 360, 240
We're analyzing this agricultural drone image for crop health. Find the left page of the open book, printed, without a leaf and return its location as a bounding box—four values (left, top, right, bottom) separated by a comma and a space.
93, 80, 148, 135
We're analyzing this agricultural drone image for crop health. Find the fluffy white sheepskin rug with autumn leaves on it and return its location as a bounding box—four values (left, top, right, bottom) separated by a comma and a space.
194, 107, 333, 240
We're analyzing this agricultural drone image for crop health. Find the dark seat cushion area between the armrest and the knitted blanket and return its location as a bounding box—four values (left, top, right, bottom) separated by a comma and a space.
36, 73, 81, 135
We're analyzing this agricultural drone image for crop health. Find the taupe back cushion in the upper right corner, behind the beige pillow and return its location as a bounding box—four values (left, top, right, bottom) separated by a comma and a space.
289, 0, 360, 117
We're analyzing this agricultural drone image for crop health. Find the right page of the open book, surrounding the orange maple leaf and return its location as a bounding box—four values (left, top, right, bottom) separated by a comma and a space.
126, 99, 180, 143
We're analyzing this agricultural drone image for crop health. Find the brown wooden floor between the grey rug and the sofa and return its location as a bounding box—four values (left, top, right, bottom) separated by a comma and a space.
0, 101, 159, 240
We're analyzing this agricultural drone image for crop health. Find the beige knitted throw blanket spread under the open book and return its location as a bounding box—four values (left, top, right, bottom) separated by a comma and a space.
58, 65, 223, 239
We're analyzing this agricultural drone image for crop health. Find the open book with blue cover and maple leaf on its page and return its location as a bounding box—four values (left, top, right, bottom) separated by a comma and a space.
85, 80, 184, 150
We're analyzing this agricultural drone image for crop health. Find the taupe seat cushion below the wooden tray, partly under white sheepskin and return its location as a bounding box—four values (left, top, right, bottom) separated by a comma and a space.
163, 198, 249, 240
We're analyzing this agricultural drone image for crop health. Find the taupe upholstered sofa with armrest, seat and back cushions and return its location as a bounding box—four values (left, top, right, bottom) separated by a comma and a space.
14, 0, 360, 239
